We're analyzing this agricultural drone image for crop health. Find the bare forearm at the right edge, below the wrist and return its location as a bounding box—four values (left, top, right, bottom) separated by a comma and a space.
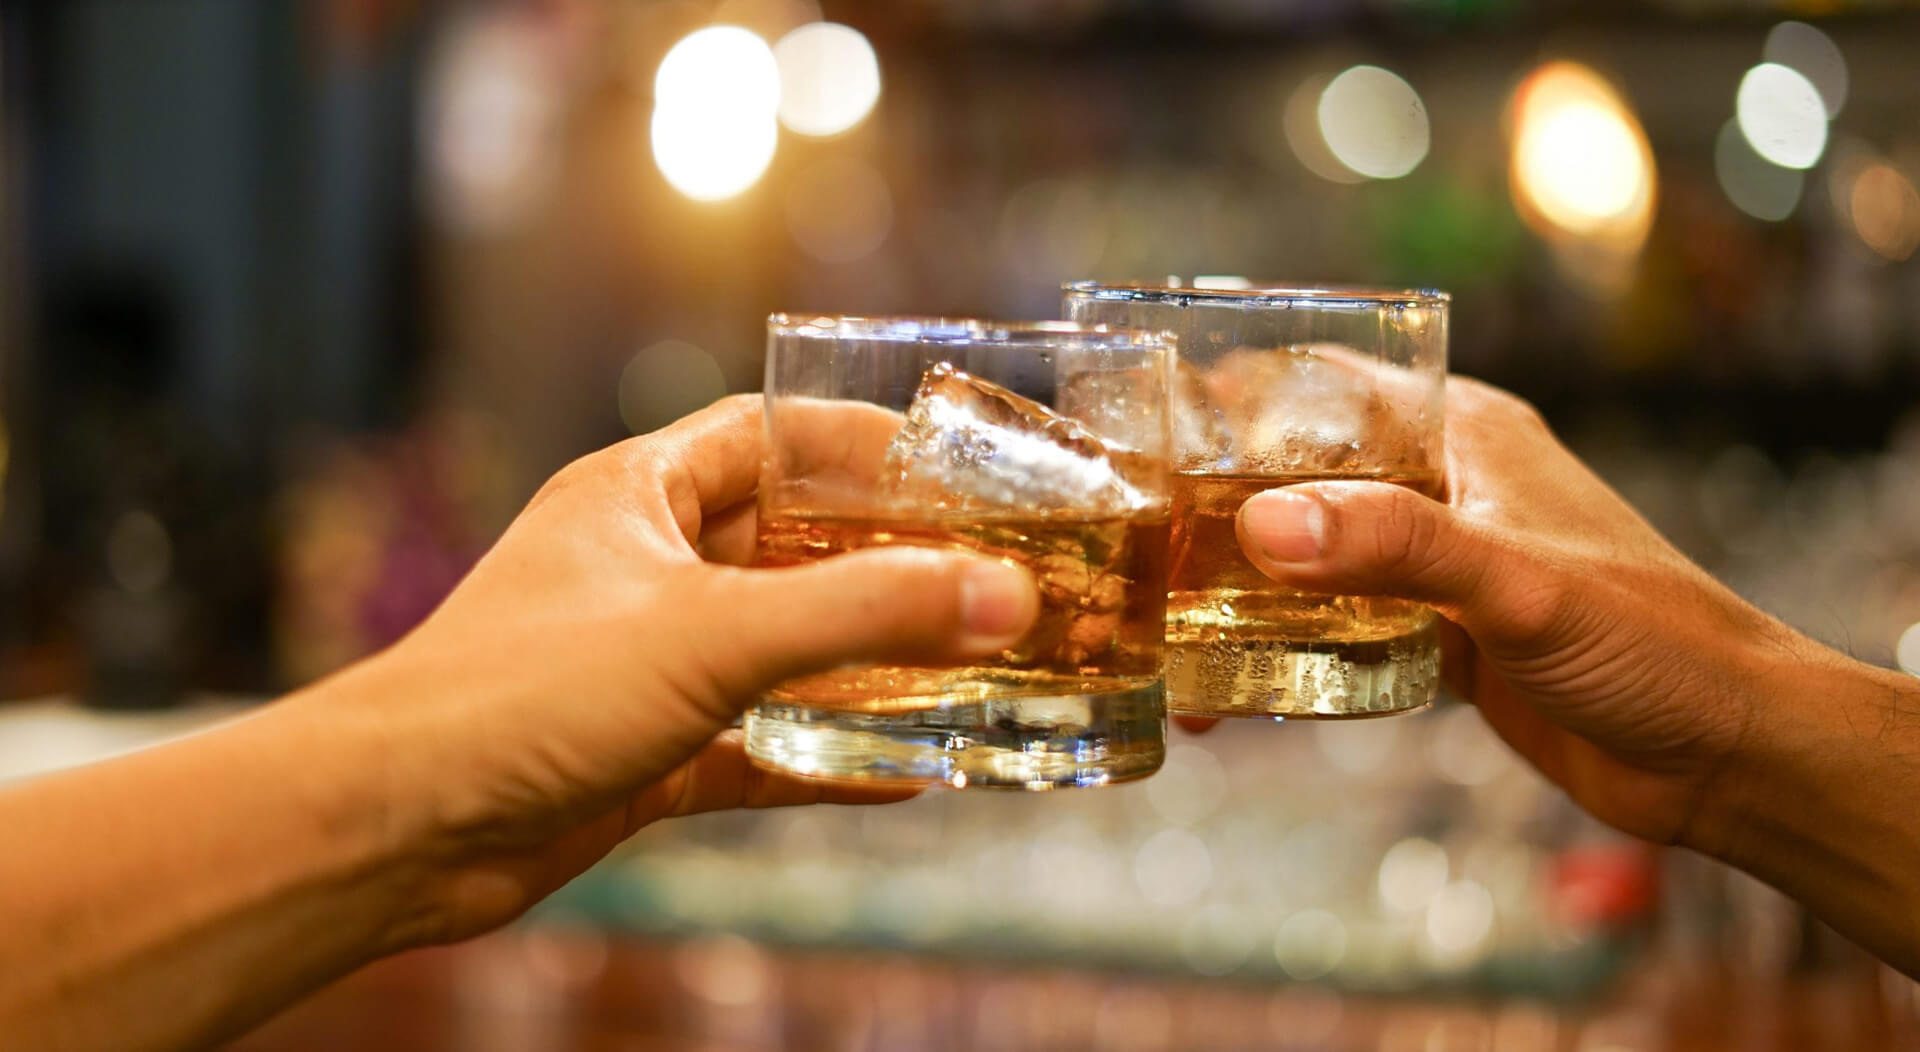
1688, 639, 1920, 975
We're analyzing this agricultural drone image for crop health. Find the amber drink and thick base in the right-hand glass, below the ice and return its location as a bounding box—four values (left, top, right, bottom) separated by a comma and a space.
1167, 472, 1440, 718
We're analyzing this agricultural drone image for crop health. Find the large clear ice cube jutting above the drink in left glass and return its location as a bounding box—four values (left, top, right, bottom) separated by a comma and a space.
883, 363, 1162, 516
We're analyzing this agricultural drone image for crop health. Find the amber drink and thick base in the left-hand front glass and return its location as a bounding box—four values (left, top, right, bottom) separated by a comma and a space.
747, 509, 1167, 789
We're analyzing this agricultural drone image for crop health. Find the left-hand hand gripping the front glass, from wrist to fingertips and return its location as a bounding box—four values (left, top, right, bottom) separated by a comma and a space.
330, 397, 1039, 939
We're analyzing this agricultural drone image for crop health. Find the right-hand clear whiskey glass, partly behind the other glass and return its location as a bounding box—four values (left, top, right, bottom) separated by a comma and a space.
1066, 278, 1450, 718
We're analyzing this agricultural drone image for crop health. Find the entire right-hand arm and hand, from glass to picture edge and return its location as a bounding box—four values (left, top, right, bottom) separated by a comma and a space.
1238, 380, 1920, 975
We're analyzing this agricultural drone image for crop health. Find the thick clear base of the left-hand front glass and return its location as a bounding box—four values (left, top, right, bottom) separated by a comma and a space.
745, 683, 1165, 789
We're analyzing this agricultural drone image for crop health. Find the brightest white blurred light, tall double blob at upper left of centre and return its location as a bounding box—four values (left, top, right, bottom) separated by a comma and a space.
653, 25, 780, 202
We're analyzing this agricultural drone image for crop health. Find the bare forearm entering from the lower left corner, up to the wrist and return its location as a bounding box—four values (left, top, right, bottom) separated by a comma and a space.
0, 697, 432, 1050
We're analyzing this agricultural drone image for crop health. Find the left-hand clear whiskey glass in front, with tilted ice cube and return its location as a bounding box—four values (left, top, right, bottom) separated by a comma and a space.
745, 315, 1173, 789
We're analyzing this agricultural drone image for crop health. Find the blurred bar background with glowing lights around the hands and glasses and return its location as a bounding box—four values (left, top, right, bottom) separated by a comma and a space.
0, 0, 1920, 1052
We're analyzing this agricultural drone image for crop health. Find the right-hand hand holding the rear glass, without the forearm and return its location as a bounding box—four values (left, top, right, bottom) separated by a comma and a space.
1238, 380, 1807, 843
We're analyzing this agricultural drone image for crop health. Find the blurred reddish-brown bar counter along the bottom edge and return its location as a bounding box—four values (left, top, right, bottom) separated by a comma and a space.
230, 929, 1920, 1052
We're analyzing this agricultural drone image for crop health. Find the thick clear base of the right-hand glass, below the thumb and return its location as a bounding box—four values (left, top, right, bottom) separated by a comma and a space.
1165, 624, 1440, 720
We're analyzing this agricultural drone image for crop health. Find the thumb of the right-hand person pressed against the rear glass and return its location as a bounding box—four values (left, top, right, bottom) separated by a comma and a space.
1236, 482, 1501, 612
